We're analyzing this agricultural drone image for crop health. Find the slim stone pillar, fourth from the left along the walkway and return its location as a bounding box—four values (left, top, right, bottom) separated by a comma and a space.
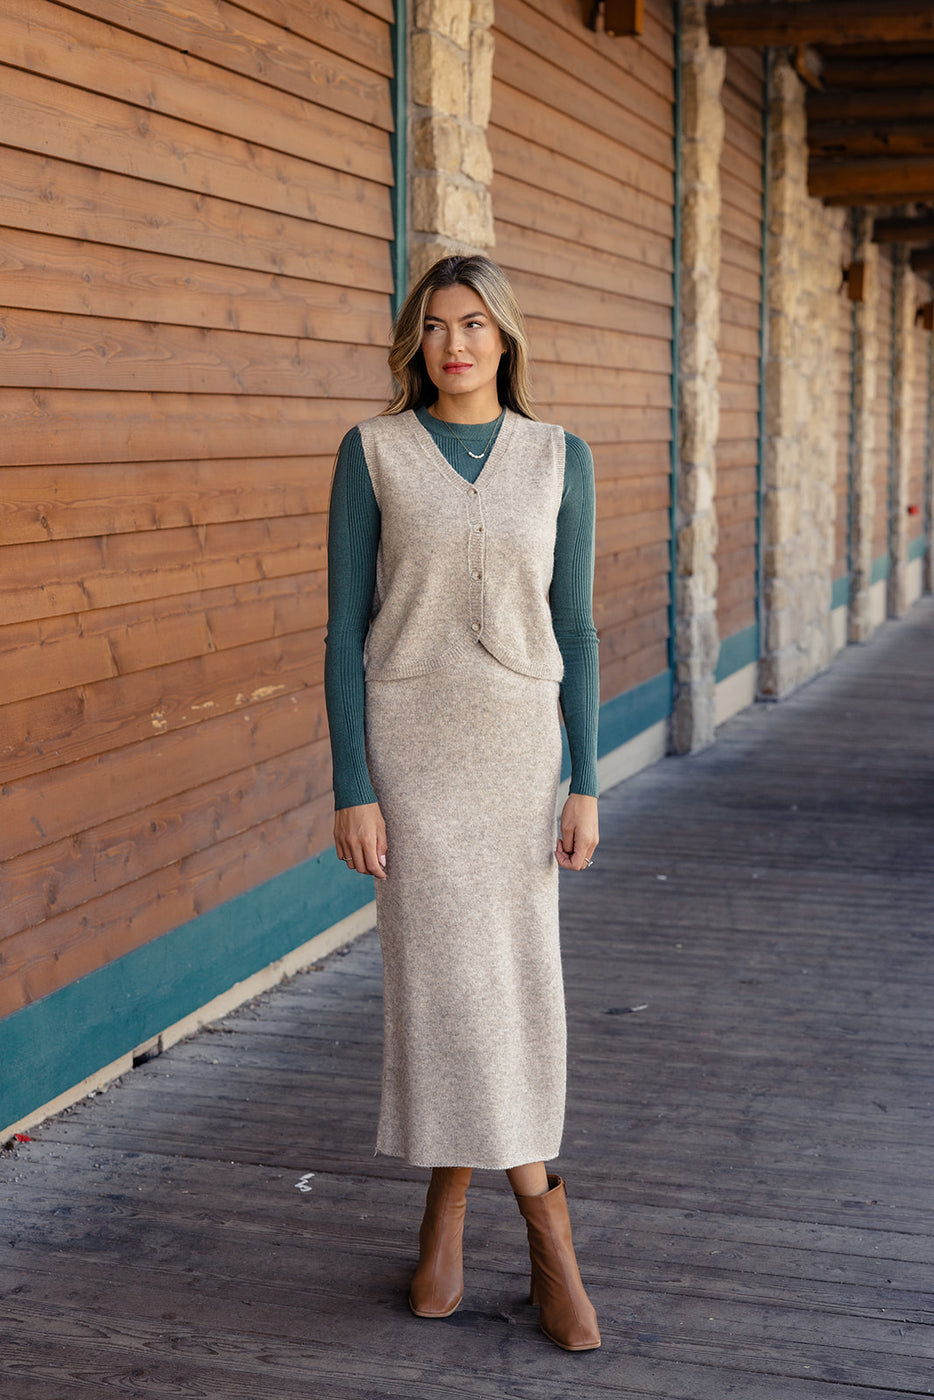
849, 213, 879, 641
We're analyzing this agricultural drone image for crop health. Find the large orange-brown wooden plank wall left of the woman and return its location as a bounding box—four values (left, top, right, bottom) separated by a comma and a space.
0, 0, 392, 1015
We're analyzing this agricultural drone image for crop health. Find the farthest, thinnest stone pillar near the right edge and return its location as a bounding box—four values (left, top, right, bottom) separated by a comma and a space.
886, 246, 914, 617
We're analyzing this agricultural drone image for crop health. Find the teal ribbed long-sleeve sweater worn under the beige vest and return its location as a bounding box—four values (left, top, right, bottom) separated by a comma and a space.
325, 409, 599, 808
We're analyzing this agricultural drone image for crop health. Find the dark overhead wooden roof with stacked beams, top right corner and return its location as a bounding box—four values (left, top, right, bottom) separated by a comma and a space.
707, 0, 934, 224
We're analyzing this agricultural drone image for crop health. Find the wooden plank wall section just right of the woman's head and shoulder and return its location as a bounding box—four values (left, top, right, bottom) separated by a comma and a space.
490, 0, 674, 699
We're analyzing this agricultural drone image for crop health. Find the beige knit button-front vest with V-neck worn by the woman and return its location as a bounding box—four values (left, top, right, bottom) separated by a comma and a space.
360, 409, 564, 680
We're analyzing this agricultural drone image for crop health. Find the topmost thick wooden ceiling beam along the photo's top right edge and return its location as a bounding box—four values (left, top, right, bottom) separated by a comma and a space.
707, 0, 934, 48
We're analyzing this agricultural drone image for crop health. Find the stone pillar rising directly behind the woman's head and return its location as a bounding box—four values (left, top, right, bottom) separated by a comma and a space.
409, 0, 494, 281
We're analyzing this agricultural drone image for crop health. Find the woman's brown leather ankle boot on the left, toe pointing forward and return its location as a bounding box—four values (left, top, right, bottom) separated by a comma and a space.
409, 1166, 471, 1317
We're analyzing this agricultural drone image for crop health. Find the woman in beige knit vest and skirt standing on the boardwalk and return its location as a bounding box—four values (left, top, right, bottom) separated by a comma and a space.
325, 256, 599, 1351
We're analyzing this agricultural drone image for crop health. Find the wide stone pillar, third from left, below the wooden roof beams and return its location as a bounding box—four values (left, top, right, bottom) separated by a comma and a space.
759, 56, 844, 700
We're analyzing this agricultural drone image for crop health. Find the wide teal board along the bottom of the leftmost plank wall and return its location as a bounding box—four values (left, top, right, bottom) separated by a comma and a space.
0, 847, 372, 1126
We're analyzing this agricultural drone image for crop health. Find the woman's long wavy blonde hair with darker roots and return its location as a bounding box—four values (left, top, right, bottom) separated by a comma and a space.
382, 253, 535, 419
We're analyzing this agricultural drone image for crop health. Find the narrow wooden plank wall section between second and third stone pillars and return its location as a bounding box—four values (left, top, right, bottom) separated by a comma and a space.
717, 49, 765, 640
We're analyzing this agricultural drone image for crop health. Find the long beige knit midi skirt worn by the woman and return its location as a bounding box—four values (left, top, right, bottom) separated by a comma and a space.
365, 645, 566, 1168
